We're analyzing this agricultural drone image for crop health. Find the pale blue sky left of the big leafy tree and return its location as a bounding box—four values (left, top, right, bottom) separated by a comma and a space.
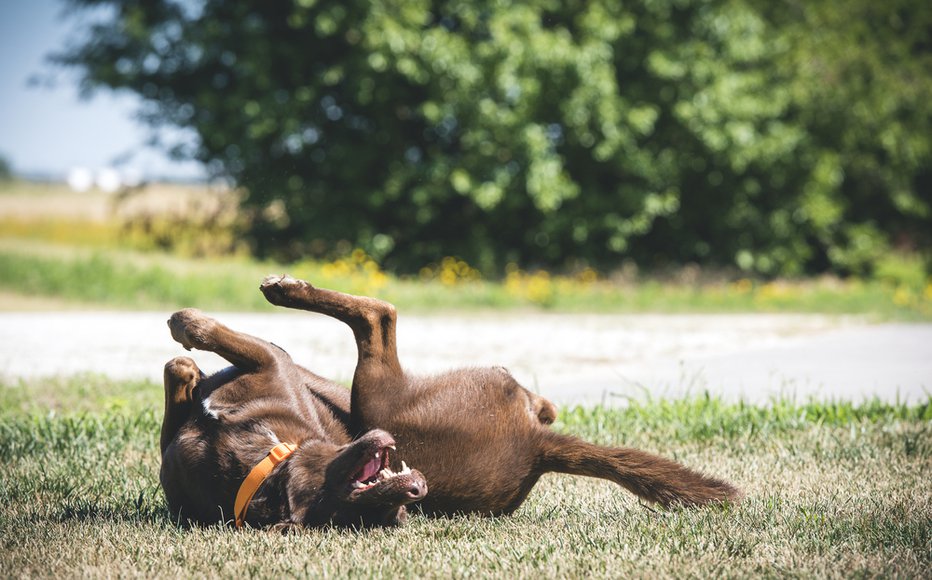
0, 0, 204, 179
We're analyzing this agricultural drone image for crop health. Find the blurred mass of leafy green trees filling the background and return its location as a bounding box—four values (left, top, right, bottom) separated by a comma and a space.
54, 0, 932, 275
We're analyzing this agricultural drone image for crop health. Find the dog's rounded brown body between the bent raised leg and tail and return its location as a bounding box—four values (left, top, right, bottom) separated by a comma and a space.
379, 370, 546, 514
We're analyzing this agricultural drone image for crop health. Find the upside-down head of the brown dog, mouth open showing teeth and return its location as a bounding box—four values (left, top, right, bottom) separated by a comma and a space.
291, 430, 427, 526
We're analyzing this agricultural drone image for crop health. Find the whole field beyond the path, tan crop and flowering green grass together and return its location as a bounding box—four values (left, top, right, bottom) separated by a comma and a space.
0, 182, 932, 320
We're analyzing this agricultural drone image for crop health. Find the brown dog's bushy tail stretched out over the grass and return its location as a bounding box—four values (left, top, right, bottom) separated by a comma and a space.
541, 431, 741, 506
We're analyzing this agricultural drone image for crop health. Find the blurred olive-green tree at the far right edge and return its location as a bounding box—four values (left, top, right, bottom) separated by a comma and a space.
761, 0, 932, 272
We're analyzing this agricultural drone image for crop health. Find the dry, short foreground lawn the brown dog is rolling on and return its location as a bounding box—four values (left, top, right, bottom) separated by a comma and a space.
0, 375, 932, 578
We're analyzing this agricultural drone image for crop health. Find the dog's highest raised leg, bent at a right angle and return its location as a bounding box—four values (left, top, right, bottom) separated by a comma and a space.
260, 276, 404, 429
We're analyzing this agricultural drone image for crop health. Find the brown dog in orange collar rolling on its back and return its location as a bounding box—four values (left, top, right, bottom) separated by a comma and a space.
161, 277, 740, 526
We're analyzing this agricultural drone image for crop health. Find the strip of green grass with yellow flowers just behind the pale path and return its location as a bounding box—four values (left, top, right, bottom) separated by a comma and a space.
0, 237, 932, 320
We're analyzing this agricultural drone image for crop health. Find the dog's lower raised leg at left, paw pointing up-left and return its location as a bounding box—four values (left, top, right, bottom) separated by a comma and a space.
168, 308, 284, 372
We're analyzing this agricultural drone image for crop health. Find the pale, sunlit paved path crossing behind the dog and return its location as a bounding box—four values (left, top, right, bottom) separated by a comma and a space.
0, 312, 932, 404
